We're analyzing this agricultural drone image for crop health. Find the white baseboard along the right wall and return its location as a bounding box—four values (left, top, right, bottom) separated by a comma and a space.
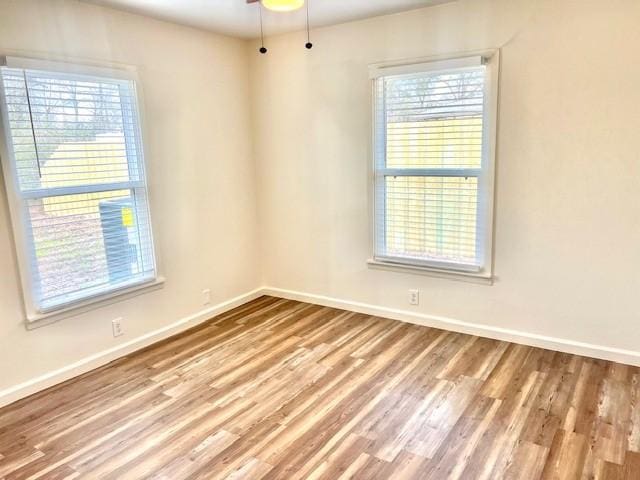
262, 287, 640, 366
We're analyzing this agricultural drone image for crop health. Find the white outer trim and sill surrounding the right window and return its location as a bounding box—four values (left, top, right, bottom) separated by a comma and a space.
367, 49, 500, 285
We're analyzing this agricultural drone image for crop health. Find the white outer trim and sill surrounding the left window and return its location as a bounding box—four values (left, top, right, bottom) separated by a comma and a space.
0, 56, 165, 329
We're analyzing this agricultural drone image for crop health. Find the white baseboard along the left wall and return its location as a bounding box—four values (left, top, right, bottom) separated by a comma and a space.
0, 288, 263, 407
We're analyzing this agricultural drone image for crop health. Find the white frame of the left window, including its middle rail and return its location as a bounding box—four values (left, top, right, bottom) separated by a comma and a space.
0, 56, 164, 328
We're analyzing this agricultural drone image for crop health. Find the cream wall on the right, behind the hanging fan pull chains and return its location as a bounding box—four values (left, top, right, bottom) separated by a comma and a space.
250, 0, 640, 351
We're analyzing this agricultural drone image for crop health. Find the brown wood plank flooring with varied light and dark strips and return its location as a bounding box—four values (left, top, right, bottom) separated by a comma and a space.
0, 297, 640, 480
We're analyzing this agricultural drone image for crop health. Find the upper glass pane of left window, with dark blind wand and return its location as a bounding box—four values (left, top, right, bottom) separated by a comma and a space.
3, 69, 139, 191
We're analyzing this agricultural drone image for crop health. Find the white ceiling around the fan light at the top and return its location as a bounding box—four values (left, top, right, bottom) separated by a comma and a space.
84, 0, 452, 38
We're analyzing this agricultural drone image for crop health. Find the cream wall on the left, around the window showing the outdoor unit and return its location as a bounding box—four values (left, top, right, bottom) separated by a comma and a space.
0, 0, 259, 391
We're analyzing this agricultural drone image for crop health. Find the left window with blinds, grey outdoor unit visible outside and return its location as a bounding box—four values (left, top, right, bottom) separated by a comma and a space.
0, 58, 156, 320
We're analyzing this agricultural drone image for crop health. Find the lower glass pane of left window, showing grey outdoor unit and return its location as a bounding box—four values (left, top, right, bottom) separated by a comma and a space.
27, 190, 154, 309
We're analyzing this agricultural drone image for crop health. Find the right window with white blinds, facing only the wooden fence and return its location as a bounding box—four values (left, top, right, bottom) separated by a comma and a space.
372, 57, 497, 276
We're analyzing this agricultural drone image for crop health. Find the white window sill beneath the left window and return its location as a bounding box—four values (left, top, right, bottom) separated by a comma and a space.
25, 277, 165, 330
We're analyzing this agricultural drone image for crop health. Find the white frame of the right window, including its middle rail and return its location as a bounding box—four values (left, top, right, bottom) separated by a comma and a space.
367, 49, 500, 284
